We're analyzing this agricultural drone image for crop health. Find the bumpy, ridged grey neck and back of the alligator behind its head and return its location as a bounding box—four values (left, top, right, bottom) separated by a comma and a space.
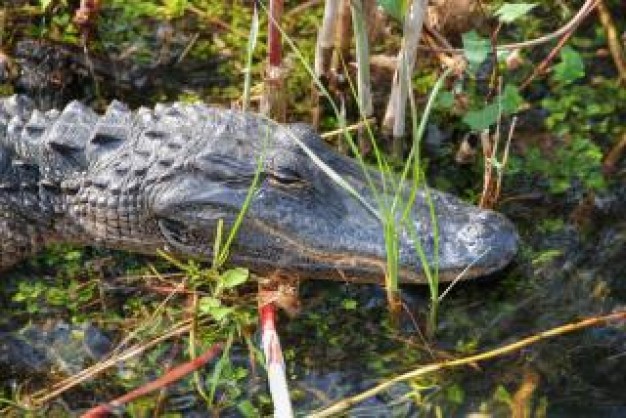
0, 96, 272, 268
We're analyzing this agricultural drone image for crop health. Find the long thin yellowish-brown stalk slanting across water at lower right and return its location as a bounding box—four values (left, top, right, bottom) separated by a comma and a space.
309, 310, 626, 418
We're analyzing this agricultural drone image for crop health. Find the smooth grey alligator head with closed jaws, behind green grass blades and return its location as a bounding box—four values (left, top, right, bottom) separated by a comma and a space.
143, 108, 518, 283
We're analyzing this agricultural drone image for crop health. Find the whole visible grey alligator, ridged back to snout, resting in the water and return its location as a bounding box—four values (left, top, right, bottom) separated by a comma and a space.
0, 96, 518, 283
